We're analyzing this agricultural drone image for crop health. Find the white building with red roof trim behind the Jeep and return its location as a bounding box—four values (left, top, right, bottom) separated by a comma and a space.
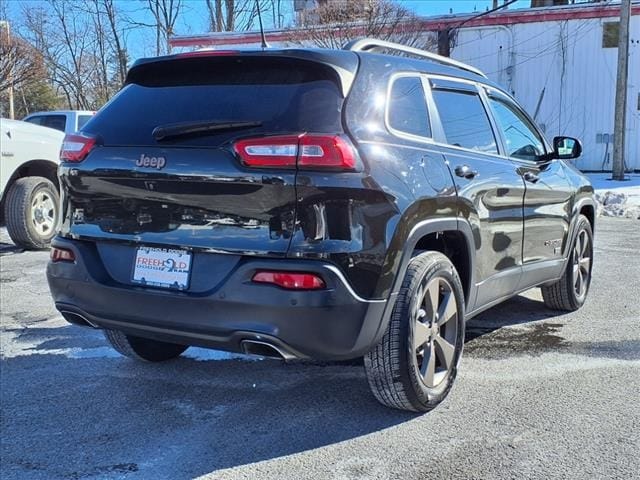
170, 0, 640, 171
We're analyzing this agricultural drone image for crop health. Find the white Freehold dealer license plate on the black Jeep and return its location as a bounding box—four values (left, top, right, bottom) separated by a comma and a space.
133, 247, 191, 290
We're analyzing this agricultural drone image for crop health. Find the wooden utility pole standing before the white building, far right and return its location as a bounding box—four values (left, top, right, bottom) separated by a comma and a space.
611, 0, 631, 180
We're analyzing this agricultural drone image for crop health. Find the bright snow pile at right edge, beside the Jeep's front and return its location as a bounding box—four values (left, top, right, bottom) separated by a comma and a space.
587, 173, 640, 219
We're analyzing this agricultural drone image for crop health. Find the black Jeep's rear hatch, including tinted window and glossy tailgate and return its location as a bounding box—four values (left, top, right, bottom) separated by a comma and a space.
61, 50, 357, 264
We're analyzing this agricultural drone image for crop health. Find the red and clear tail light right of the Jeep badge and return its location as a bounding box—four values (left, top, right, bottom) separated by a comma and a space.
234, 134, 356, 170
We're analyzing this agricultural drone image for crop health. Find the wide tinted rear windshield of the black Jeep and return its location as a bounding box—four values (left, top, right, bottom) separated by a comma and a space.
82, 57, 343, 146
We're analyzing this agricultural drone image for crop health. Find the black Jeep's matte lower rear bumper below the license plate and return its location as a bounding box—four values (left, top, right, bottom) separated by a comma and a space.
47, 238, 386, 360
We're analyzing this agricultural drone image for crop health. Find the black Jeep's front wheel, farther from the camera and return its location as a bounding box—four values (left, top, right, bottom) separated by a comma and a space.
540, 215, 593, 312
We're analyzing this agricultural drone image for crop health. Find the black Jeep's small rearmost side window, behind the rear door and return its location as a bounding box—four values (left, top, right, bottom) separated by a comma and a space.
387, 77, 431, 137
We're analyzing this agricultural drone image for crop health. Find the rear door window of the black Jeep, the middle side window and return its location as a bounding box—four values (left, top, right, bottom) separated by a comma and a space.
433, 90, 498, 154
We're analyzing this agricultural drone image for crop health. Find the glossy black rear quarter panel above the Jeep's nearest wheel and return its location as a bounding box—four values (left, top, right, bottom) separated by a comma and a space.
289, 55, 457, 299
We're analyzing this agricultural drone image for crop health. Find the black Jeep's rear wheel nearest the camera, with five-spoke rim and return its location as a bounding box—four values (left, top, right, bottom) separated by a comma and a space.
364, 252, 465, 412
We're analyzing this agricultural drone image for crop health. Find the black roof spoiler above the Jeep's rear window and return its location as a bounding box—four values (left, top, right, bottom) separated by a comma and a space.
125, 49, 359, 98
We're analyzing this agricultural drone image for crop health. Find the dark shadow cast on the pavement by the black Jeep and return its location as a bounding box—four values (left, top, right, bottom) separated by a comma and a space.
1, 297, 576, 478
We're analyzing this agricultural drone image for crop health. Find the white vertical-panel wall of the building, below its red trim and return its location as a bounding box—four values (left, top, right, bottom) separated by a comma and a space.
452, 15, 640, 170
